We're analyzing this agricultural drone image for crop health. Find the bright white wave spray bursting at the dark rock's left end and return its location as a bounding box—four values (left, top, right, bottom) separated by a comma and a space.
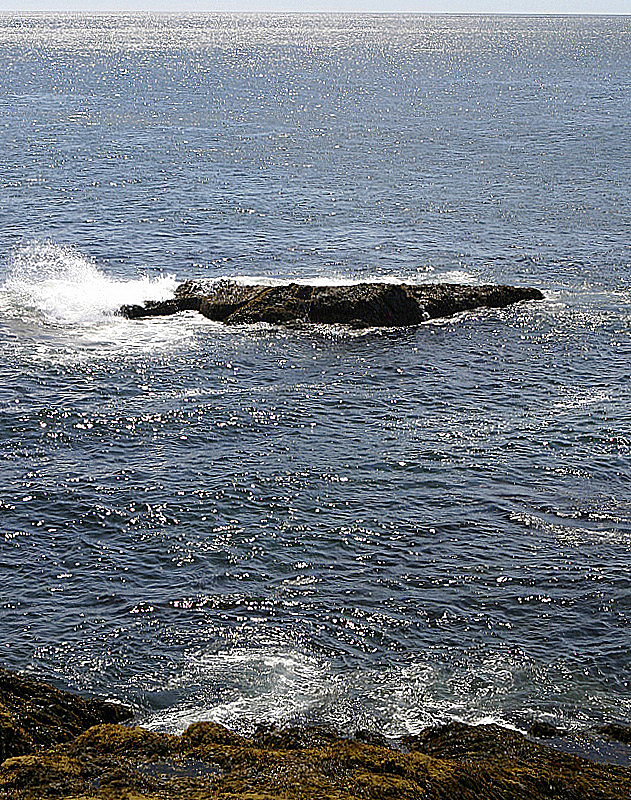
0, 242, 177, 326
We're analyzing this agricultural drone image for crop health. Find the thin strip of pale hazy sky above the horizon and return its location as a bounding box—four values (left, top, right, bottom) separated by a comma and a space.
0, 0, 631, 14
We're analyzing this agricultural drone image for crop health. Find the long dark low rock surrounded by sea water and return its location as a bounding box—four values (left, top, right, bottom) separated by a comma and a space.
120, 281, 543, 328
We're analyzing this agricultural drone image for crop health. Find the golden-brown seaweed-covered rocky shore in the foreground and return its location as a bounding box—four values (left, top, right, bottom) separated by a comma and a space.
0, 670, 631, 800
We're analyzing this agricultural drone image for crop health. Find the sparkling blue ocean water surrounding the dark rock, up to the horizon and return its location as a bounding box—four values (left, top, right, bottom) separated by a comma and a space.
0, 15, 631, 737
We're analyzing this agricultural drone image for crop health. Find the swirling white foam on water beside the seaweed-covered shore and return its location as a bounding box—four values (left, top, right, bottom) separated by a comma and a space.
143, 646, 570, 738
